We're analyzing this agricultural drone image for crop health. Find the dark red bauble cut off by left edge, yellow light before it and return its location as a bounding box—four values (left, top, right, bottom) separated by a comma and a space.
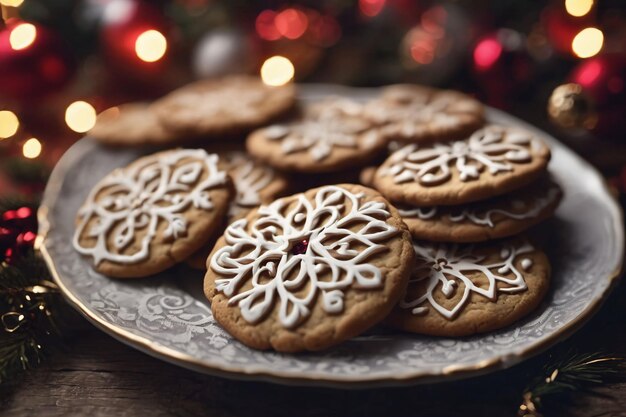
0, 20, 75, 100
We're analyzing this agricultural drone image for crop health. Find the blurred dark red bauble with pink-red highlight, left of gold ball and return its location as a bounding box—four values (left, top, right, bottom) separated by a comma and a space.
472, 29, 534, 108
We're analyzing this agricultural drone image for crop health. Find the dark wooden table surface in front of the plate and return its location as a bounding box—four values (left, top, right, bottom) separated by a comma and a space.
0, 266, 626, 417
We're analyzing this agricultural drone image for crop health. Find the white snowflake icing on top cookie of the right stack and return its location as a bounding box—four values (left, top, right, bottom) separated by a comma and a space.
382, 126, 533, 186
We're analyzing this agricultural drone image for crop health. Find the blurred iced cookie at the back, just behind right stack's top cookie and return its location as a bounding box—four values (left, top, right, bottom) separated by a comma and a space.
365, 84, 484, 142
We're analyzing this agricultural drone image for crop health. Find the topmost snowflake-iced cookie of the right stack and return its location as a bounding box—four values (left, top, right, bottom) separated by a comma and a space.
374, 125, 550, 206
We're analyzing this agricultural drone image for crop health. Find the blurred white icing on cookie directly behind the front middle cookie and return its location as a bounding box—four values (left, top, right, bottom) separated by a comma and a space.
265, 100, 378, 161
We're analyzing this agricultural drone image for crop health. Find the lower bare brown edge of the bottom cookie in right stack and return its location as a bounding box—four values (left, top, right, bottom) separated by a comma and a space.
385, 240, 552, 337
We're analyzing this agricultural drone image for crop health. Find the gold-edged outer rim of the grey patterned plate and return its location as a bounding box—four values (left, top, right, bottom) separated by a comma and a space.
38, 85, 624, 388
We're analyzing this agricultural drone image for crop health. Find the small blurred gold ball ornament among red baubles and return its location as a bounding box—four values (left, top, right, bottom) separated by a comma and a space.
548, 83, 598, 130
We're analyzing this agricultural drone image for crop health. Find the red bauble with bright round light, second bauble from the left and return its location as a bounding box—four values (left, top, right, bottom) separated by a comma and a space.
100, 0, 171, 84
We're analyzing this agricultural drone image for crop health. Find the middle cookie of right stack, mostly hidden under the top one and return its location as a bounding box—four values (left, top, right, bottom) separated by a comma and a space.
398, 179, 563, 242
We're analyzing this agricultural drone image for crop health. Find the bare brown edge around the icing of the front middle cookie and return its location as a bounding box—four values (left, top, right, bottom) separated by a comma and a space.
204, 184, 415, 352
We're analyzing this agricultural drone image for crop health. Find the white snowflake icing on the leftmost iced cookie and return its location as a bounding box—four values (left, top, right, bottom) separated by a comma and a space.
73, 149, 227, 265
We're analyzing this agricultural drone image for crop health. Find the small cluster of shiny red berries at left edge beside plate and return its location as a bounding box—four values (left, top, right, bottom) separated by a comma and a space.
0, 207, 37, 262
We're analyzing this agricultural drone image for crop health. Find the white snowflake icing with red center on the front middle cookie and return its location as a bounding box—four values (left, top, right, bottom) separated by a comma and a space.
210, 186, 398, 328
